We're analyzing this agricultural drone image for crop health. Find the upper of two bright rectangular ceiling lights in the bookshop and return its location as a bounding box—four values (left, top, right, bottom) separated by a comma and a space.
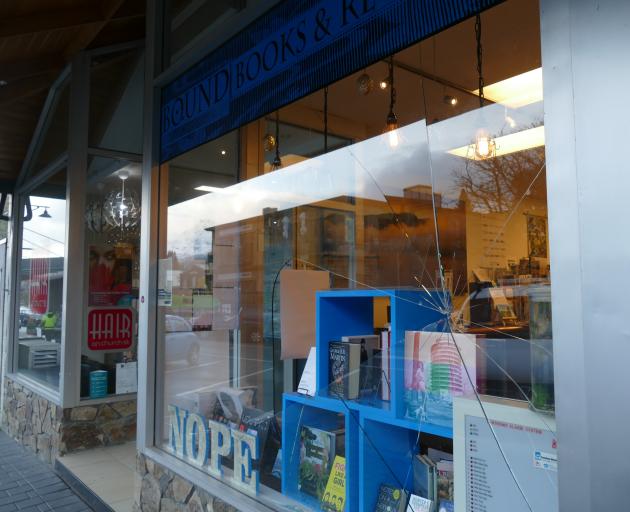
473, 68, 543, 108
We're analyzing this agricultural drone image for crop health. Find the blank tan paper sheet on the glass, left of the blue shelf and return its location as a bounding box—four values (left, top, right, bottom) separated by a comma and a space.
280, 269, 330, 359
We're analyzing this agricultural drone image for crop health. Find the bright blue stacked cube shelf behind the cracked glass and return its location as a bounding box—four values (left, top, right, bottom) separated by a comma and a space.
282, 289, 453, 512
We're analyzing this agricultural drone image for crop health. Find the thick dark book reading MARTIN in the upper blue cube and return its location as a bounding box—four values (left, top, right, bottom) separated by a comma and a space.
328, 341, 361, 400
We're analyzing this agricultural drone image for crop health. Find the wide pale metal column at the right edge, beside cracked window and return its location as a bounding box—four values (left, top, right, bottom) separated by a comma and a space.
541, 0, 630, 512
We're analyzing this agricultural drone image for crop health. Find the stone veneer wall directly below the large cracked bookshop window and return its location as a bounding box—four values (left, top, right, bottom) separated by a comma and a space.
133, 453, 238, 512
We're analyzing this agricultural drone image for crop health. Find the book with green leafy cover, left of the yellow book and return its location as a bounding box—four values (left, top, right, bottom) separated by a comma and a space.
298, 425, 336, 501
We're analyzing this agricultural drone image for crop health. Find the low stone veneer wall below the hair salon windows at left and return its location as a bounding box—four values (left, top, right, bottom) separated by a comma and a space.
1, 379, 136, 463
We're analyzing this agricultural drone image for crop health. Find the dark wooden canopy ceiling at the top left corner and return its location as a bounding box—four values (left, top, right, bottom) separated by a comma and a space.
0, 0, 145, 189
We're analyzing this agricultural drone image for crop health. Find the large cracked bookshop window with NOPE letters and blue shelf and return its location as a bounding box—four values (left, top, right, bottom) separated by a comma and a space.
156, 1, 557, 511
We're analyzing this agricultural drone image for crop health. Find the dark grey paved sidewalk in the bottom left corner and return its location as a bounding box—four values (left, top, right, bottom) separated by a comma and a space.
0, 431, 92, 512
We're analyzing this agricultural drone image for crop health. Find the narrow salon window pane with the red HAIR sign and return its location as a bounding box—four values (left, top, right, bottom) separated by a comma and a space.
81, 157, 141, 399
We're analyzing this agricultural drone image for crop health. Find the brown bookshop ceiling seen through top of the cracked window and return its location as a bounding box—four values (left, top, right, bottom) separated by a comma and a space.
298, 0, 541, 136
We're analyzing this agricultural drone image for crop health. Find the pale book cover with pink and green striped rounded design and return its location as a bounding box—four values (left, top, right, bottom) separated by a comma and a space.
404, 331, 477, 428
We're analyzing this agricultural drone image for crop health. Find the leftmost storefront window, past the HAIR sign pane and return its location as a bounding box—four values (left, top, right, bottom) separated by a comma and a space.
16, 170, 66, 390
